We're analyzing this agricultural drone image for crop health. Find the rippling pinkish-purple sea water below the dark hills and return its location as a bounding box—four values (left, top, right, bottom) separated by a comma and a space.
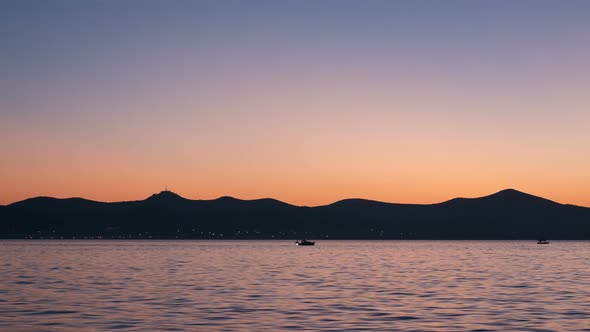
0, 241, 590, 331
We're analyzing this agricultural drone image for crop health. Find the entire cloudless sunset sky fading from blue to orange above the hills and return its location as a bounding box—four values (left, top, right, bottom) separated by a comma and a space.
0, 0, 590, 206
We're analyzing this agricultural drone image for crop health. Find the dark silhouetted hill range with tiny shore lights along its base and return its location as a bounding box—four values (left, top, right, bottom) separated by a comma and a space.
0, 189, 590, 239
